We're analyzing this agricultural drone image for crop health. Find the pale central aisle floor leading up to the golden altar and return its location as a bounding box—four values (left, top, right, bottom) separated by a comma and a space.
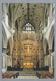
18, 68, 38, 79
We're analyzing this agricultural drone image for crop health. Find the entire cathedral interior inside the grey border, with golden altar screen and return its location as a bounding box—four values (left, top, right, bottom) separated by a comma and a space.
2, 3, 55, 78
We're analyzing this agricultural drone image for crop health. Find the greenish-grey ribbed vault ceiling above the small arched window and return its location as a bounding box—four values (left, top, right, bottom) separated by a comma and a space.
9, 3, 48, 30
